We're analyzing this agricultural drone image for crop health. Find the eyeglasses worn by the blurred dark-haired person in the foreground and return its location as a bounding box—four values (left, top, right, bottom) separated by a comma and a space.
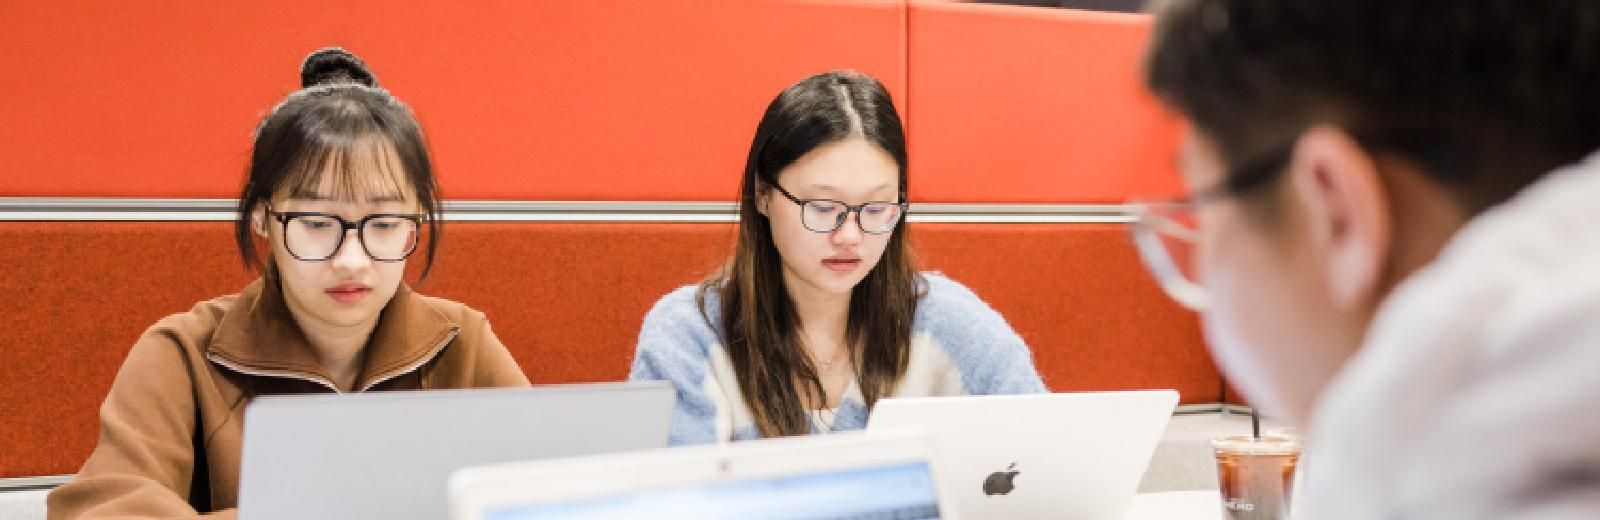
1128, 139, 1298, 310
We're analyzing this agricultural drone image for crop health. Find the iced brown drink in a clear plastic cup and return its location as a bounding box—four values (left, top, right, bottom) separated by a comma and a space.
1211, 434, 1301, 520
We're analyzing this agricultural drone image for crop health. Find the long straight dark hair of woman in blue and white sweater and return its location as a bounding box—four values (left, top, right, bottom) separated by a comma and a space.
699, 70, 923, 437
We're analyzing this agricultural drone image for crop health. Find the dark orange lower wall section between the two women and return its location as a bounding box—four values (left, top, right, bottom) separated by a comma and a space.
418, 222, 734, 384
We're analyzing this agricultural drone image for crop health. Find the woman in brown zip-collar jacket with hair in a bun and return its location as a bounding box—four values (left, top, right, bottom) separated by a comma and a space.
50, 48, 528, 518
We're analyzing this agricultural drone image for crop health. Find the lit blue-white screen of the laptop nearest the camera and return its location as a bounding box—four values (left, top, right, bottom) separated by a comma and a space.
485, 462, 939, 520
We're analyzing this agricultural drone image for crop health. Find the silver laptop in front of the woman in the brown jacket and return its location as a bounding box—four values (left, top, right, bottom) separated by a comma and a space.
238, 382, 677, 520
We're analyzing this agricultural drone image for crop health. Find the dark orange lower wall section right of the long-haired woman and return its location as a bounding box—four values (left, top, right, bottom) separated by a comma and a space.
912, 224, 1221, 403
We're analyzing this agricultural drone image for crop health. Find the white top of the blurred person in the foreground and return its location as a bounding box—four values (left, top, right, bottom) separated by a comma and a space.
1296, 154, 1600, 520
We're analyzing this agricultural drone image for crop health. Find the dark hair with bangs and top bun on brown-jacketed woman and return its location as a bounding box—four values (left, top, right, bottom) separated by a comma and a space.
234, 48, 442, 278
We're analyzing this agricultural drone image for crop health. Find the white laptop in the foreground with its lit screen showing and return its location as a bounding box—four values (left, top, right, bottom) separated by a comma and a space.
450, 430, 955, 520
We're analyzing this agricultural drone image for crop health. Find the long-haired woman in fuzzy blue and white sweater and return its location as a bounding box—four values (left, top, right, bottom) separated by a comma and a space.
629, 72, 1045, 445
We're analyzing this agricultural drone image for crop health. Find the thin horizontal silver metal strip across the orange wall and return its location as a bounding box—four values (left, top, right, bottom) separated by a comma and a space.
0, 197, 1133, 224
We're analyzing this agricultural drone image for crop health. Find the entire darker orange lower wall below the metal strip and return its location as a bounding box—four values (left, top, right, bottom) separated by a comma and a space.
0, 222, 1221, 477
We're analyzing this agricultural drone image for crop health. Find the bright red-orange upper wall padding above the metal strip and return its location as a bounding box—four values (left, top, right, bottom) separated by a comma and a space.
0, 0, 1178, 202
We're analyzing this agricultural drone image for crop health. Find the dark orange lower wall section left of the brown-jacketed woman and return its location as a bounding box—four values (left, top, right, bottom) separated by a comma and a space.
0, 222, 254, 478
